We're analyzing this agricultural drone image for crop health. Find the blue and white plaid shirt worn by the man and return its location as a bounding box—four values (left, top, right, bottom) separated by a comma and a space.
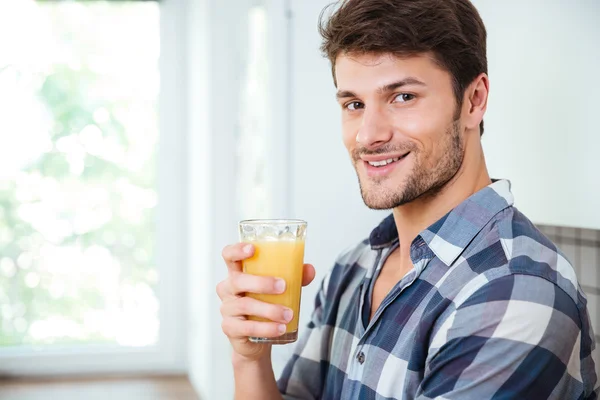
278, 181, 598, 400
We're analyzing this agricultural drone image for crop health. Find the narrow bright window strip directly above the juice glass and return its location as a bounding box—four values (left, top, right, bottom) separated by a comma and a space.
236, 0, 291, 219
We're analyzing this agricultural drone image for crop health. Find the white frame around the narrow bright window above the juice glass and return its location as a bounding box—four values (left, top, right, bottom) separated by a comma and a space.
186, 0, 292, 399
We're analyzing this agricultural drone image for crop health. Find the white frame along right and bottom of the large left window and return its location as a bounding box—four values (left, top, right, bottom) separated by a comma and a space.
0, 0, 188, 377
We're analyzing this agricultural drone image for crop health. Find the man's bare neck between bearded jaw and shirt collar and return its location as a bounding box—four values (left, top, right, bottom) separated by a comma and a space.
393, 142, 491, 261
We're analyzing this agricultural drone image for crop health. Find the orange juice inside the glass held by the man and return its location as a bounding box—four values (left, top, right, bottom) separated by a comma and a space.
243, 239, 304, 333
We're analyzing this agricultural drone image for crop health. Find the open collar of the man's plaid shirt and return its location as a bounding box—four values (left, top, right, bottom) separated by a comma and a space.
369, 180, 514, 266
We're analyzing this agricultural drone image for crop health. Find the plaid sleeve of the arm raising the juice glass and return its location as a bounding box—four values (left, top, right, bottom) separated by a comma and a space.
277, 274, 329, 400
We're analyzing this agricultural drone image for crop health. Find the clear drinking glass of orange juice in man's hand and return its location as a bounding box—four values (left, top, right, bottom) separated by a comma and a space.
239, 219, 307, 344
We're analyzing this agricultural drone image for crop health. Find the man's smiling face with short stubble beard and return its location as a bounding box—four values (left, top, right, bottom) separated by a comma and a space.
335, 54, 464, 209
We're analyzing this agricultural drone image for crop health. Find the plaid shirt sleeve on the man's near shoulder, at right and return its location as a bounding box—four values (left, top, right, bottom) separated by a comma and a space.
417, 275, 596, 400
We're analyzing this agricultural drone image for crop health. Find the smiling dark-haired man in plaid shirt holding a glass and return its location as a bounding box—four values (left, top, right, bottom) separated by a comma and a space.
217, 0, 598, 400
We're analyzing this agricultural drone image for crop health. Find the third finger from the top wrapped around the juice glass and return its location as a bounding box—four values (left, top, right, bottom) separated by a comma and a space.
221, 297, 294, 324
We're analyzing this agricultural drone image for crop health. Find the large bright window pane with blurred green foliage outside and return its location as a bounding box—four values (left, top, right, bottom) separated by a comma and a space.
0, 0, 159, 351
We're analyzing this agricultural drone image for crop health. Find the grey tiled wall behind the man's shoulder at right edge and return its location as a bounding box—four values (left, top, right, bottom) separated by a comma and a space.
539, 226, 600, 344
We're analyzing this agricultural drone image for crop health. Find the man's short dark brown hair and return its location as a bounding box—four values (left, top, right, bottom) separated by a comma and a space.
319, 0, 487, 135
